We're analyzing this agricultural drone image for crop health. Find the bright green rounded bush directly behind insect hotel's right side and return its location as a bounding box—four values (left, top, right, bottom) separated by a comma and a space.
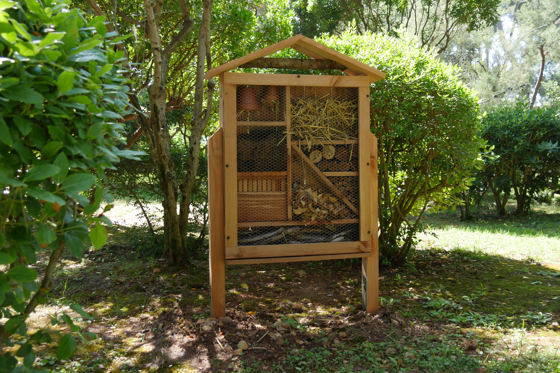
319, 33, 483, 265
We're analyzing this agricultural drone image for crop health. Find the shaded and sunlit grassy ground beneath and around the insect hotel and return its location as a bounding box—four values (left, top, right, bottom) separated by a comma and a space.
16, 196, 560, 373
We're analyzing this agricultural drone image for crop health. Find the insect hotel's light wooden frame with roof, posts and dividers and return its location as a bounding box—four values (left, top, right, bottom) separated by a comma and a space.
207, 35, 384, 317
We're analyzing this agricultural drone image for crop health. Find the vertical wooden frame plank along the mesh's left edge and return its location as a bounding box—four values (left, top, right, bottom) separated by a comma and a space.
222, 84, 238, 247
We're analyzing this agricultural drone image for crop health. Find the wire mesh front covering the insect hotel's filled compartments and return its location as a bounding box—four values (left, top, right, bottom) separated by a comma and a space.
237, 86, 360, 246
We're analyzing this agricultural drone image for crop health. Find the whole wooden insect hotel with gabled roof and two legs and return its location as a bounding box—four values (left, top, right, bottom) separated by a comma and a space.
205, 35, 385, 317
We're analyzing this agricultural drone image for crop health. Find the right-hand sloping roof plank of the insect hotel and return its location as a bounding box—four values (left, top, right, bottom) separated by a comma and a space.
291, 38, 385, 83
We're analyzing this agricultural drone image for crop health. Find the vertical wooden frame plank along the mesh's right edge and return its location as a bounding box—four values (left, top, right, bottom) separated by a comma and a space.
358, 87, 372, 241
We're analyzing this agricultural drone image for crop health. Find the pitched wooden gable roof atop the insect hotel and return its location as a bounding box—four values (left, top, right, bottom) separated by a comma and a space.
204, 35, 385, 83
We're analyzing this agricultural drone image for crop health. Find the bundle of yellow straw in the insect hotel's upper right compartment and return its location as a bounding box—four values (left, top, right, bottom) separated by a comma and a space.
289, 96, 358, 143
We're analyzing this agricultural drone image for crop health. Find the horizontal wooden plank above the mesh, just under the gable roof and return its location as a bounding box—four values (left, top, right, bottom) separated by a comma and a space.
224, 73, 369, 87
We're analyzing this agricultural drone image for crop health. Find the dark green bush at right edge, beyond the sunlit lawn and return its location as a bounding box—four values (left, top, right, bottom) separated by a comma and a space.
482, 105, 560, 213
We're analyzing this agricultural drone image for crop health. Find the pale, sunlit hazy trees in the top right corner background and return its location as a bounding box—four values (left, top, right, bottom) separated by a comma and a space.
442, 0, 560, 107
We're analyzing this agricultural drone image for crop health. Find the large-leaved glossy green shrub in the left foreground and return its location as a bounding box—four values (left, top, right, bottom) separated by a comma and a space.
0, 0, 139, 372
